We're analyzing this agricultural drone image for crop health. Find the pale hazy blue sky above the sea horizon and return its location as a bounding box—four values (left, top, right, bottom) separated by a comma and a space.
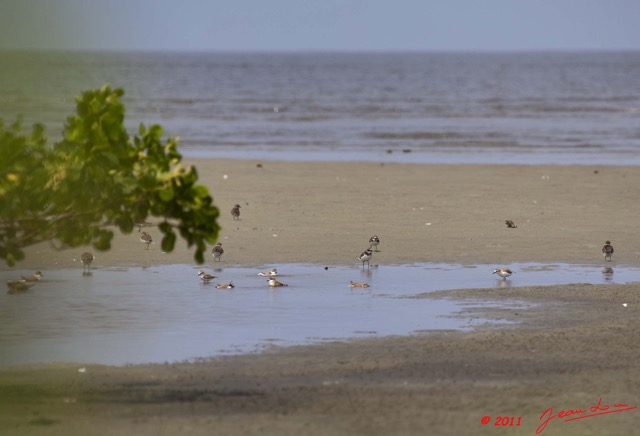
0, 0, 640, 51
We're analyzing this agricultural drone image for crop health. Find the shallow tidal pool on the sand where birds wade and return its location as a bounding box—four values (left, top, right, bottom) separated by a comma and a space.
0, 263, 640, 366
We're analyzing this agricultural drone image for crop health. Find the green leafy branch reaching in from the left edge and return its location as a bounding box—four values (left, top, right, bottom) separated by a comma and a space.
0, 85, 219, 265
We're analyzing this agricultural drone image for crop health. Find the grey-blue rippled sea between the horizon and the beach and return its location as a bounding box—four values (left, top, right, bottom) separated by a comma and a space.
0, 52, 640, 165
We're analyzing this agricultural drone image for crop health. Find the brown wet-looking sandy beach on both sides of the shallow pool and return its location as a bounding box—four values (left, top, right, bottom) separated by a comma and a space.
0, 160, 640, 435
